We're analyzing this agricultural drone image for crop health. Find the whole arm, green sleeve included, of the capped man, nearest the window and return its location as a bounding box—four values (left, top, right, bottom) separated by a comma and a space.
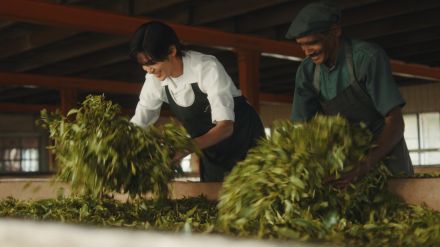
334, 46, 405, 187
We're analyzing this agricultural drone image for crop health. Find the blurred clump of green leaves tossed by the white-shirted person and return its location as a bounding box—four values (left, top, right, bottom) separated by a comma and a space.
39, 95, 195, 198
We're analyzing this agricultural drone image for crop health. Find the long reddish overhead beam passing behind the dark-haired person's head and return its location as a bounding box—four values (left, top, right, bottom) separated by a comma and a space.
0, 0, 304, 57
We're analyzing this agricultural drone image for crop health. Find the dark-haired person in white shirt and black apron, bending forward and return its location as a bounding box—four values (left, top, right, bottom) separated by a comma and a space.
130, 21, 264, 181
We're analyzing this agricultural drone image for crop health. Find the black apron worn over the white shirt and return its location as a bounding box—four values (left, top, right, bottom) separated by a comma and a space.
165, 83, 264, 182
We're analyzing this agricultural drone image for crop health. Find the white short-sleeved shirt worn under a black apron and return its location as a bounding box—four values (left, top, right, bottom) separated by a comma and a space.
131, 51, 241, 127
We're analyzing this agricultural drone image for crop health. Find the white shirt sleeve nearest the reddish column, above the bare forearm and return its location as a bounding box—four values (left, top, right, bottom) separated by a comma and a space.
200, 56, 237, 123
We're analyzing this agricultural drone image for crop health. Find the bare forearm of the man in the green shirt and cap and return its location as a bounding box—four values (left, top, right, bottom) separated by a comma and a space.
367, 107, 405, 167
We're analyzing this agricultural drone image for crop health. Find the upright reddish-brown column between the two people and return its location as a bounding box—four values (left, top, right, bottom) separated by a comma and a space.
237, 49, 260, 112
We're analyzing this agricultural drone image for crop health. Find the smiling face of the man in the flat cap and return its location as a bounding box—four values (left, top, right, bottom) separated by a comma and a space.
296, 29, 340, 64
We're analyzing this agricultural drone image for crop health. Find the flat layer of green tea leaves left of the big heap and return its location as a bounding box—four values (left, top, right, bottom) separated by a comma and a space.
0, 196, 217, 232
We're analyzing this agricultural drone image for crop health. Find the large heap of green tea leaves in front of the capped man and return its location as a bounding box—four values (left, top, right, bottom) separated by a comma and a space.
218, 116, 440, 246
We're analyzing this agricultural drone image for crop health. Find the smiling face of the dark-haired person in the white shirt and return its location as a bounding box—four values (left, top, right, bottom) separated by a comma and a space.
137, 53, 173, 81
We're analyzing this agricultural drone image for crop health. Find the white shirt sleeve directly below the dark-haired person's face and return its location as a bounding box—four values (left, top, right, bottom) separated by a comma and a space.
130, 75, 163, 127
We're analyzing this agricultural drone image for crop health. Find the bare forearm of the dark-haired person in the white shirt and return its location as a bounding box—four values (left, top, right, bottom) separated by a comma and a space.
194, 120, 234, 149
